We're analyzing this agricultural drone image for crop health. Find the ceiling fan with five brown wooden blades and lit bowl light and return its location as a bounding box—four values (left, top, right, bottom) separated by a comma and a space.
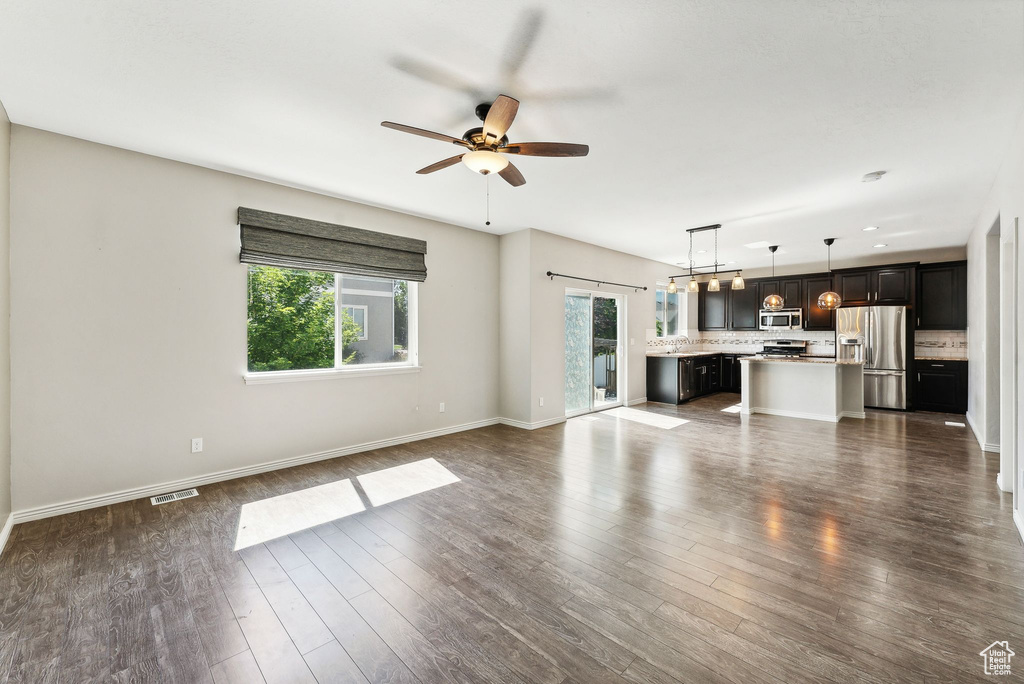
381, 95, 590, 187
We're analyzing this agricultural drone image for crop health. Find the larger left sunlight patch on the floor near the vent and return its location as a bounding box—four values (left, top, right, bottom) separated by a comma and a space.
234, 479, 366, 551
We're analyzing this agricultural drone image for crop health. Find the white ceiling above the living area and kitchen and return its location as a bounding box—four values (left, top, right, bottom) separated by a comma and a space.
0, 0, 1024, 267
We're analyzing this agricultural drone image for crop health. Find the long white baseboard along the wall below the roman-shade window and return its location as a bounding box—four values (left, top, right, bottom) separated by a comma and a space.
8, 418, 499, 524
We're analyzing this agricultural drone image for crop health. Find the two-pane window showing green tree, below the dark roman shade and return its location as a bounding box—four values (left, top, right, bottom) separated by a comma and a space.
248, 264, 416, 373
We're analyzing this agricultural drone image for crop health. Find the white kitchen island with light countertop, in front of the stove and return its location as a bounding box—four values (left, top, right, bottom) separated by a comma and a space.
739, 356, 864, 423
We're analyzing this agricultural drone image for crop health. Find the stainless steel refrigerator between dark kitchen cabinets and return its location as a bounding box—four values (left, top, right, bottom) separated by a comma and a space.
836, 306, 906, 409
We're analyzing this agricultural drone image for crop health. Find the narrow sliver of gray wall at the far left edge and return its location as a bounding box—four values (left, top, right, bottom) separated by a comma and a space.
0, 102, 11, 532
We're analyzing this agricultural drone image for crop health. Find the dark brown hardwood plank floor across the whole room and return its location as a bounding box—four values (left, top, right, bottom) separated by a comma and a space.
0, 394, 1024, 684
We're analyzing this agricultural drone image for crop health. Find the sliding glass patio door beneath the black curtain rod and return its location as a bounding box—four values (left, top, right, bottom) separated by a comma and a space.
565, 289, 626, 418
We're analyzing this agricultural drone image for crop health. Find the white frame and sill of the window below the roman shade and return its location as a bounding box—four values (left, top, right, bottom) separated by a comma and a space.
242, 263, 421, 385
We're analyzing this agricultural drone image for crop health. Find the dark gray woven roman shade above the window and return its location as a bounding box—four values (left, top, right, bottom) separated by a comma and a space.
239, 207, 427, 283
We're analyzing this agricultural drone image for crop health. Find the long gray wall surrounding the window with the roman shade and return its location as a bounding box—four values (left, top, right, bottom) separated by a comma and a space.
6, 126, 499, 511
